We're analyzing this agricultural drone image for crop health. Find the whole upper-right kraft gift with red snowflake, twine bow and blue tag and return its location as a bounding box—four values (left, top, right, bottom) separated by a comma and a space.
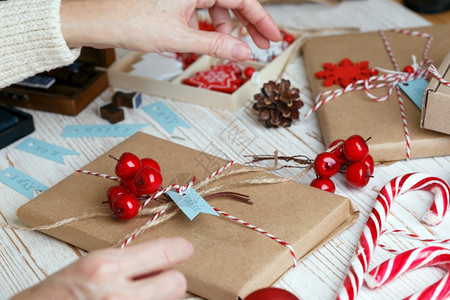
303, 25, 450, 162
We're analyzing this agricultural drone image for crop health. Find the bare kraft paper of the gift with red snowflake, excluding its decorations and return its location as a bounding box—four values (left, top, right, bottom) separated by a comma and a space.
303, 24, 450, 162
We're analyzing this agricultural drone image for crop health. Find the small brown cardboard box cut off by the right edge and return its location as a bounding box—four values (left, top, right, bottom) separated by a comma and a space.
420, 52, 450, 134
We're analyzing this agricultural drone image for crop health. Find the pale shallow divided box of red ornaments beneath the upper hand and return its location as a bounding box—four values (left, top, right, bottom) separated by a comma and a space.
108, 30, 306, 110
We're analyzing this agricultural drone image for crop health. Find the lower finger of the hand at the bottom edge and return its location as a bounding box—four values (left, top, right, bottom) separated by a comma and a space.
132, 270, 187, 300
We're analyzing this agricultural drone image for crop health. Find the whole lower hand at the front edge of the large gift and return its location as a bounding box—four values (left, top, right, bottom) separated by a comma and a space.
13, 238, 194, 300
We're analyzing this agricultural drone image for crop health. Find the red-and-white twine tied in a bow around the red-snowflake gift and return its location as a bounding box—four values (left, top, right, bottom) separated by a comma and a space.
305, 29, 433, 159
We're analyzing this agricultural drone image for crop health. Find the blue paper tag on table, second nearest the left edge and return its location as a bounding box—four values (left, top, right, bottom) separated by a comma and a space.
16, 137, 80, 164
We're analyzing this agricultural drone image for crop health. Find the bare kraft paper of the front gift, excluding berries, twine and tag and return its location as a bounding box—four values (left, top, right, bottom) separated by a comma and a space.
18, 133, 359, 300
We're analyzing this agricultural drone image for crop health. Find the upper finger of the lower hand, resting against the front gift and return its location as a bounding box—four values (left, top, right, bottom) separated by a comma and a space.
119, 238, 194, 278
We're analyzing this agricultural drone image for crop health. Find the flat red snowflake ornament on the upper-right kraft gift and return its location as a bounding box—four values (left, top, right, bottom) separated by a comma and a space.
315, 58, 378, 88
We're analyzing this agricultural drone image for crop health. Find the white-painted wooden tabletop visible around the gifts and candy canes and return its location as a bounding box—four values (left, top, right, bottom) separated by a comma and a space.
0, 0, 450, 299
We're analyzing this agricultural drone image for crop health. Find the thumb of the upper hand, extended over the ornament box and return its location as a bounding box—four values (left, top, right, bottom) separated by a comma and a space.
178, 28, 252, 61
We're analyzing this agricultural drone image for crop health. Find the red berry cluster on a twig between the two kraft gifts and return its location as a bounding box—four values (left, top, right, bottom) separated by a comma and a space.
310, 135, 374, 193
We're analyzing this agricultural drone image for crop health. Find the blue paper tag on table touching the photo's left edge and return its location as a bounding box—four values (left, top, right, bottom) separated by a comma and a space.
0, 167, 48, 199
